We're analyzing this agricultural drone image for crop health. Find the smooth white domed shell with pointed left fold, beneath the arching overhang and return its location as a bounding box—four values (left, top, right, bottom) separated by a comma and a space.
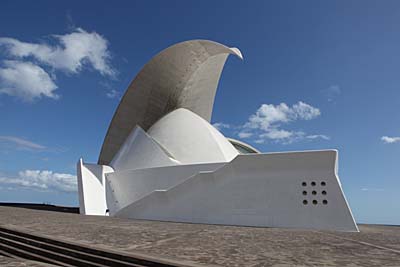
110, 108, 239, 172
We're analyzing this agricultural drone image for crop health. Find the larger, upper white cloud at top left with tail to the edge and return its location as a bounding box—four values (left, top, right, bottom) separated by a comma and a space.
0, 28, 116, 76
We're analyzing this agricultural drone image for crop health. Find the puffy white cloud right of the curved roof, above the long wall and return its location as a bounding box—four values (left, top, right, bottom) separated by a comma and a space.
239, 101, 329, 144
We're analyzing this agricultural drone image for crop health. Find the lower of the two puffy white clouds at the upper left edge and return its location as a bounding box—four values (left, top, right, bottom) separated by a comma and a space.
0, 60, 59, 101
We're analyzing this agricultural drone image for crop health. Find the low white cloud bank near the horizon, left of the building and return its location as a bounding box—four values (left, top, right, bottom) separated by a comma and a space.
0, 170, 77, 192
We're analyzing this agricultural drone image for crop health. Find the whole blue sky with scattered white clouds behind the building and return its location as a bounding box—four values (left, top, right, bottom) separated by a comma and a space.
0, 0, 400, 224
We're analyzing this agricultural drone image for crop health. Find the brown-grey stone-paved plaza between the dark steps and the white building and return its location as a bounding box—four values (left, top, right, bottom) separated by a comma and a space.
0, 207, 400, 266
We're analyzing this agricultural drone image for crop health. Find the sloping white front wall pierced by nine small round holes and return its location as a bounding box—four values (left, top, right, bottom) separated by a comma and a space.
115, 151, 358, 231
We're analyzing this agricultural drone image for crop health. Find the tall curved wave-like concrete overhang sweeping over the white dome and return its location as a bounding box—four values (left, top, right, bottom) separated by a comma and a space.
98, 40, 243, 165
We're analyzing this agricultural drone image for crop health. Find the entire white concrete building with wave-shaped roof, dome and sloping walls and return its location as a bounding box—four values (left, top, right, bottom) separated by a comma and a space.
78, 40, 358, 231
